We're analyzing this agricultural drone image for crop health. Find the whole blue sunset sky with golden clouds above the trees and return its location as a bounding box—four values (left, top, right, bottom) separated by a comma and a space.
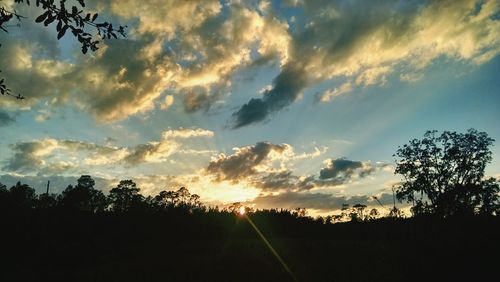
0, 0, 500, 214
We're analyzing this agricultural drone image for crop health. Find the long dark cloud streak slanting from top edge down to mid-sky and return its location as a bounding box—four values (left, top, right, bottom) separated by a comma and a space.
232, 1, 415, 128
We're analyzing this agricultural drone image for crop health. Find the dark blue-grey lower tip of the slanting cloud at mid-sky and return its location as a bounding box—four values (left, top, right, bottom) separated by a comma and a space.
232, 65, 307, 128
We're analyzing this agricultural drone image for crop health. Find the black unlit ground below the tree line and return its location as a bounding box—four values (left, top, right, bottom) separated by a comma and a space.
0, 213, 500, 281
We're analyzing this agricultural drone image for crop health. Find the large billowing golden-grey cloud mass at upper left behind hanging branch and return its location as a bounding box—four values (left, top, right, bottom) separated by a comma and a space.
0, 0, 290, 122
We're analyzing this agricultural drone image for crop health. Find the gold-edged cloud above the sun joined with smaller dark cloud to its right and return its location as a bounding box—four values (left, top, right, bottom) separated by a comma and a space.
205, 142, 387, 192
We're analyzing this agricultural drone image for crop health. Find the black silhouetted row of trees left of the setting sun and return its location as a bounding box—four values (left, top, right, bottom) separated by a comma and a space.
0, 175, 204, 214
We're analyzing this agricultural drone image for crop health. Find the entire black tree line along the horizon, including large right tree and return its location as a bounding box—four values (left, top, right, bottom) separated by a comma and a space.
0, 129, 500, 223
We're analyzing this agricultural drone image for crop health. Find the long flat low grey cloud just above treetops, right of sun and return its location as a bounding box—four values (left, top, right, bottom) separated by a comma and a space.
248, 192, 392, 211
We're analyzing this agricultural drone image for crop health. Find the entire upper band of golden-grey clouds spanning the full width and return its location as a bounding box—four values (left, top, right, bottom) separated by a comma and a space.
0, 0, 500, 124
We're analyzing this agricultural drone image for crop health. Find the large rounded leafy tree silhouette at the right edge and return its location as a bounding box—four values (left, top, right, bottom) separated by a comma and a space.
395, 129, 500, 217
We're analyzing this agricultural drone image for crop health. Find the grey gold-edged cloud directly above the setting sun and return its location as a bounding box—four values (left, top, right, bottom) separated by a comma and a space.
206, 142, 289, 183
